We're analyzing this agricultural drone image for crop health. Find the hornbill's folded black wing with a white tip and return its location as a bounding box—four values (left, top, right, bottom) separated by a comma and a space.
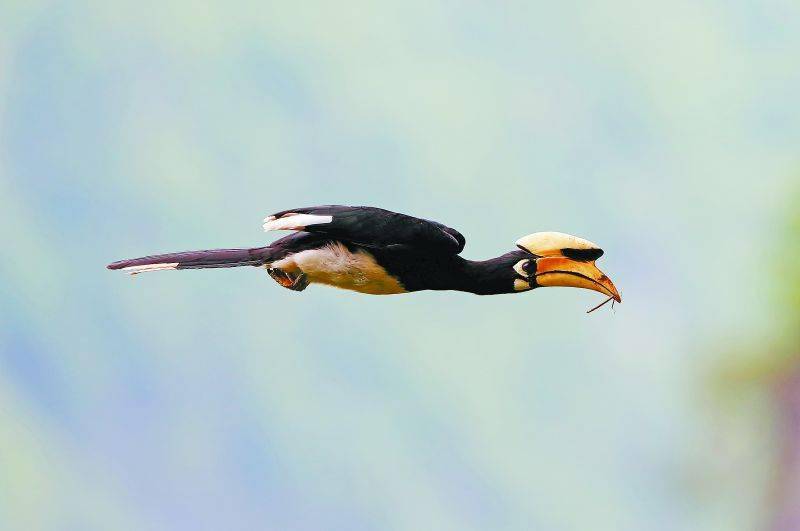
264, 205, 464, 254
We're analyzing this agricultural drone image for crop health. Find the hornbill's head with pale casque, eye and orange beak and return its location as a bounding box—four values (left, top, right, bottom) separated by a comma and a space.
514, 232, 622, 302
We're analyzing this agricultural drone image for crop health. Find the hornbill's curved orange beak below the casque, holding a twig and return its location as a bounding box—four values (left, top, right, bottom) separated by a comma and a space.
533, 256, 622, 302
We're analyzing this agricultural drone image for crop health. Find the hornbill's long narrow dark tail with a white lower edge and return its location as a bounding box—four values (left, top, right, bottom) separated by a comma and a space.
107, 247, 271, 275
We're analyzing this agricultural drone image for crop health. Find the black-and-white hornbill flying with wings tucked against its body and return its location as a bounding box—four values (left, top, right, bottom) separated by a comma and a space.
108, 205, 621, 302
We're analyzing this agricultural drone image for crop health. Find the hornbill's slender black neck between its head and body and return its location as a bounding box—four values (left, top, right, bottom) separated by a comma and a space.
446, 251, 526, 295
